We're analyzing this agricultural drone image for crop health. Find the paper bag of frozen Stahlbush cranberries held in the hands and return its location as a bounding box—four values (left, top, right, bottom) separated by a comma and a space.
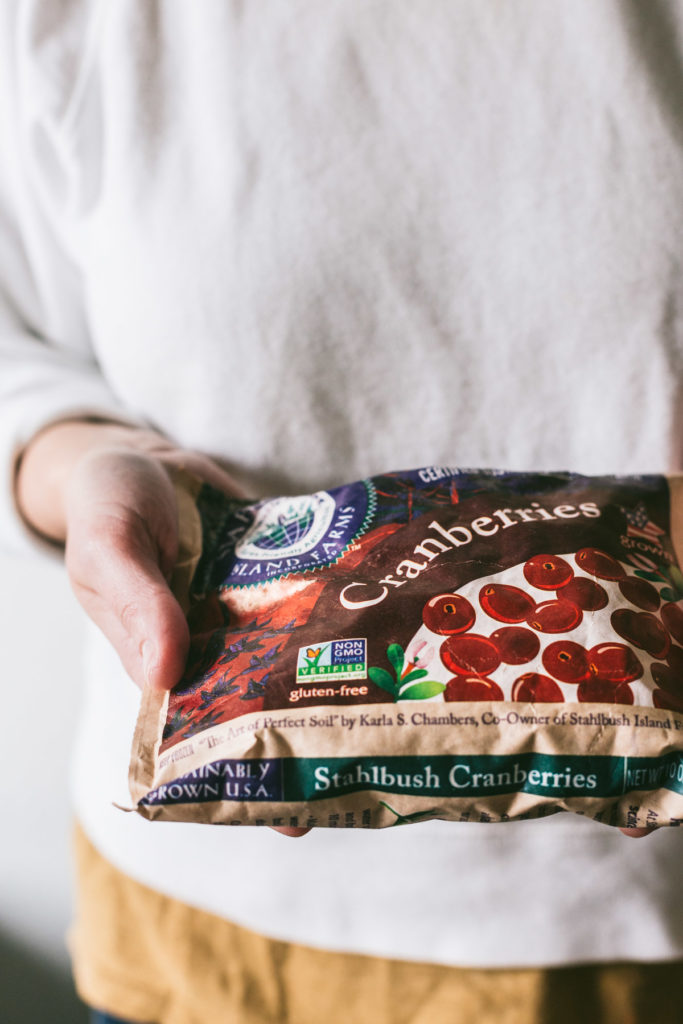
126, 467, 683, 827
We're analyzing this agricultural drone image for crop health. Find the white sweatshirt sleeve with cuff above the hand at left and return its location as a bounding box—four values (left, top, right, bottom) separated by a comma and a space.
0, 0, 144, 551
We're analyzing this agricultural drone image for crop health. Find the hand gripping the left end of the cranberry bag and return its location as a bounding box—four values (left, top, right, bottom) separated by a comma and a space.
16, 421, 308, 836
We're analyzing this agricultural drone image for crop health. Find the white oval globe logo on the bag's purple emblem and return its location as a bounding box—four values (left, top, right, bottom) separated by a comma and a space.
234, 490, 337, 561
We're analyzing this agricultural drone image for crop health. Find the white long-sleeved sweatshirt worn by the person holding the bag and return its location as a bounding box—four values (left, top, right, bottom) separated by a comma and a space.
0, 0, 683, 967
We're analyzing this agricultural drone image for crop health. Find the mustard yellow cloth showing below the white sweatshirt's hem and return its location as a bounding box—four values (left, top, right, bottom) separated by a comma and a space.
70, 827, 683, 1024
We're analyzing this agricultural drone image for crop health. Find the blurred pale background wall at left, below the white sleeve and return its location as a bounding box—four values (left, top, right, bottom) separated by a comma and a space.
0, 551, 89, 1024
